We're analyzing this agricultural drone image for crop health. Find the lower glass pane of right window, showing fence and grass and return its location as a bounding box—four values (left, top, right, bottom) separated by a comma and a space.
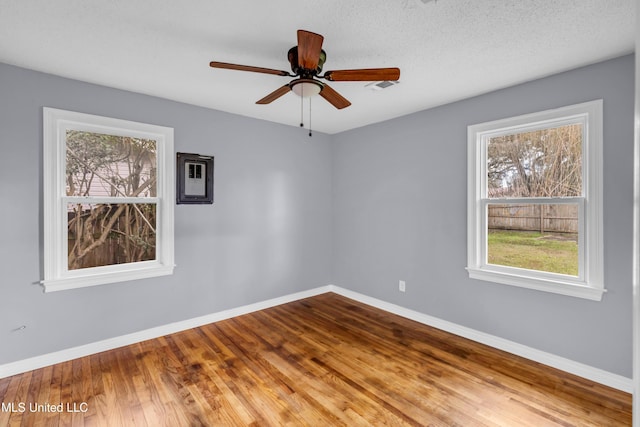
487, 203, 579, 276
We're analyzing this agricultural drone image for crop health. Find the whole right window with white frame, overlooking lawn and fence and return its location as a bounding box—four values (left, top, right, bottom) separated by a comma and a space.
467, 100, 605, 301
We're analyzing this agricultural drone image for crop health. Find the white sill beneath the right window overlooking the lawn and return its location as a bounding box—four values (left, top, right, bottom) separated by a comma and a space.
467, 267, 606, 301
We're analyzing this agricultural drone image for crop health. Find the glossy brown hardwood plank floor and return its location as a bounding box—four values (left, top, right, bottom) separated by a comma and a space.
0, 294, 631, 427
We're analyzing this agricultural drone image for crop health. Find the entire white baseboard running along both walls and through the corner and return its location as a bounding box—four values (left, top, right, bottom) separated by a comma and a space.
0, 285, 633, 393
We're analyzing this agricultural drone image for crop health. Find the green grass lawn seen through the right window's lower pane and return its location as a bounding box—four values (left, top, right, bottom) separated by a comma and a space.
488, 230, 578, 276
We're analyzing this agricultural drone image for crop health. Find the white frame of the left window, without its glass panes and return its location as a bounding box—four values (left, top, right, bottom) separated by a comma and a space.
41, 107, 175, 292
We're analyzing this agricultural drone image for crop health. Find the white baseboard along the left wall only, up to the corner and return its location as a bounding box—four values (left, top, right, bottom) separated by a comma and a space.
0, 286, 330, 378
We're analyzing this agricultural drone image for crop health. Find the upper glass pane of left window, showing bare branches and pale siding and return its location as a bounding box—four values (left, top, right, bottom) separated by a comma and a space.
65, 130, 157, 197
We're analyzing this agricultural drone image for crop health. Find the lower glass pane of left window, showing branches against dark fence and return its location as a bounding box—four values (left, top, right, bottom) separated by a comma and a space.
67, 203, 156, 270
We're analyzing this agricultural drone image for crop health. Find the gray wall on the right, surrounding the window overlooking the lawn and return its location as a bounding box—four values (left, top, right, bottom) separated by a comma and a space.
333, 56, 634, 377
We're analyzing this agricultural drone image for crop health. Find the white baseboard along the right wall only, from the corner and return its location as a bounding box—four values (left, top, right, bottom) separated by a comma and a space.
329, 285, 633, 393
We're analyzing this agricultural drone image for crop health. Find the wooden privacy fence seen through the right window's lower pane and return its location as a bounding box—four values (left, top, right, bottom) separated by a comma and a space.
487, 204, 578, 233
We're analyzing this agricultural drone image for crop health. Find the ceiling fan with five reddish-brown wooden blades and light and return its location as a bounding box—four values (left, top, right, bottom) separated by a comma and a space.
209, 30, 400, 109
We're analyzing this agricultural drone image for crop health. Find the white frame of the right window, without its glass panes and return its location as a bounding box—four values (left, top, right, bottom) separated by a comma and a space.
467, 100, 606, 301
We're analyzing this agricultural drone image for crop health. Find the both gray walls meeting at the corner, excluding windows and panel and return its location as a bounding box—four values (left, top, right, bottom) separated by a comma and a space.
0, 56, 634, 377
